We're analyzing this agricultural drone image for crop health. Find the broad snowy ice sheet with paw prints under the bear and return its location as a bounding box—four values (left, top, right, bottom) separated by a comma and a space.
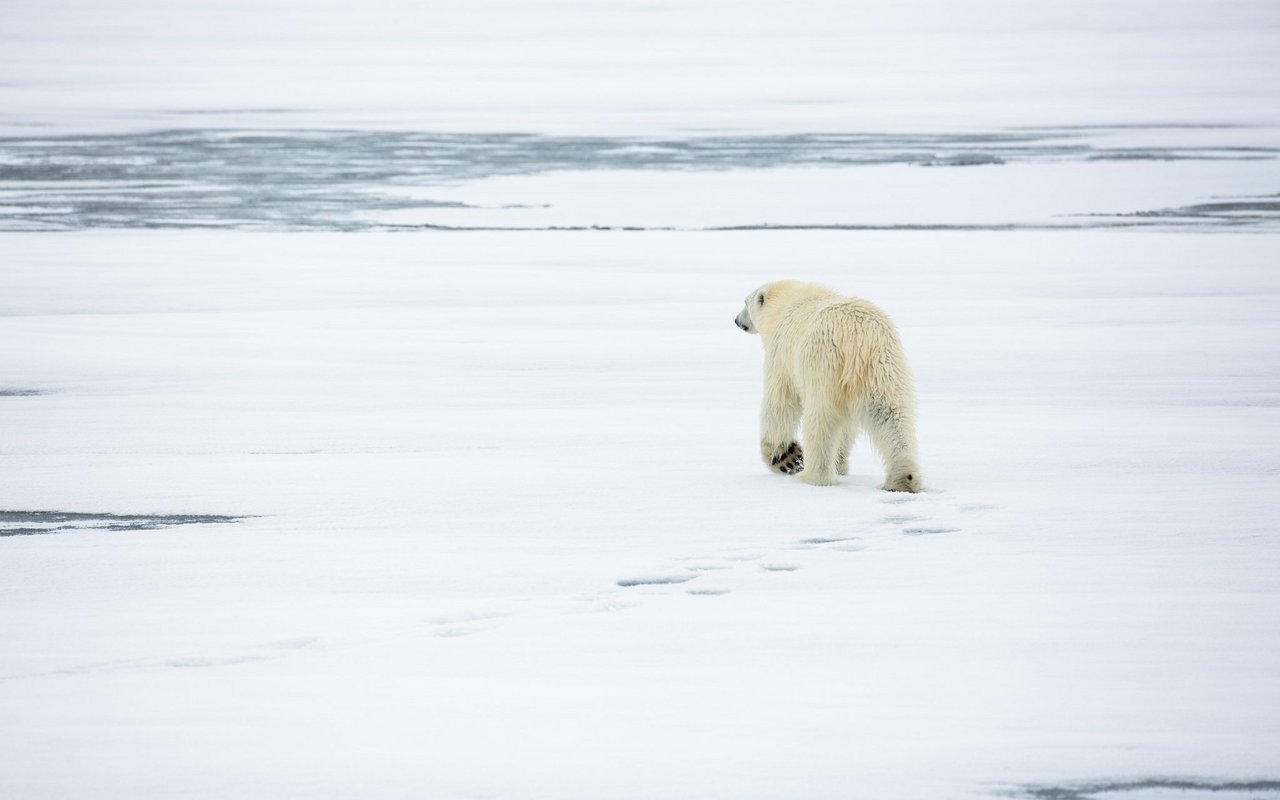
0, 232, 1280, 800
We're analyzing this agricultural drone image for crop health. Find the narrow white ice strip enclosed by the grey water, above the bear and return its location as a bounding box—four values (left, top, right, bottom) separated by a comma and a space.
365, 160, 1280, 229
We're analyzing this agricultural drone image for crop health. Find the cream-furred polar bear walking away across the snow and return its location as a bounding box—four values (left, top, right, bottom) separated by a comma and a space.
735, 280, 922, 492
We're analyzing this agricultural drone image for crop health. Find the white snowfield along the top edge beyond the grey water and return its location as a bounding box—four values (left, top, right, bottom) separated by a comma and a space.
0, 0, 1280, 134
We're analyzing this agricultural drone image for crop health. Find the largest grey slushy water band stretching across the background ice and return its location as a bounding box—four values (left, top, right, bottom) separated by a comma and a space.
0, 125, 1280, 230
